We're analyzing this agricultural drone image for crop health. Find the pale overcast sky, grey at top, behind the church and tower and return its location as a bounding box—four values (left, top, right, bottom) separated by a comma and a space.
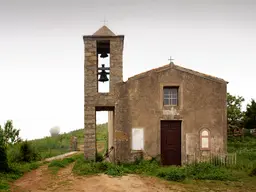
0, 0, 256, 139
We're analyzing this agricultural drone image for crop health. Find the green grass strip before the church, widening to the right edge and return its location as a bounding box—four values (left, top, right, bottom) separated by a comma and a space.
73, 136, 256, 191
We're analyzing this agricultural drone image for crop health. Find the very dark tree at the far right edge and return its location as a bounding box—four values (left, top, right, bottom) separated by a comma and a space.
245, 99, 256, 129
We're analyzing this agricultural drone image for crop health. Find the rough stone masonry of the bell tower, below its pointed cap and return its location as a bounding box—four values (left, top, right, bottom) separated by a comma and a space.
84, 36, 124, 160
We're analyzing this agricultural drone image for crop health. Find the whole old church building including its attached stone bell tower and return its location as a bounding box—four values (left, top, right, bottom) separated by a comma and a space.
83, 26, 227, 165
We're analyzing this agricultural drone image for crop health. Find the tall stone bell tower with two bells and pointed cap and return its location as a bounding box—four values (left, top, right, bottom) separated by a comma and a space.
83, 25, 124, 160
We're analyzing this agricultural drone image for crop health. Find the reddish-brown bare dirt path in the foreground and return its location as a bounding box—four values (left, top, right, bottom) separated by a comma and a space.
11, 164, 180, 192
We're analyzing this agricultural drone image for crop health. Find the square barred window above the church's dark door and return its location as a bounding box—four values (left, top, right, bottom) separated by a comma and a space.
164, 87, 178, 105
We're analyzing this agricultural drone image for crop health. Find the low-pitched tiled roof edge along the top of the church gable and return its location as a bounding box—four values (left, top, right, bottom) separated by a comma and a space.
128, 63, 228, 83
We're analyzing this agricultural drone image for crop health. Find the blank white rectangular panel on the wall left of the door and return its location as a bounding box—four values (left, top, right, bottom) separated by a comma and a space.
132, 128, 144, 150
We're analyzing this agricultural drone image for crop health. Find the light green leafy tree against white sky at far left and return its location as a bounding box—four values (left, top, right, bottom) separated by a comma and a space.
0, 120, 21, 145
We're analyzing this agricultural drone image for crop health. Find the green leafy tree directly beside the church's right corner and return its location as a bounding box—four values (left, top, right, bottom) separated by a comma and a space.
227, 93, 244, 129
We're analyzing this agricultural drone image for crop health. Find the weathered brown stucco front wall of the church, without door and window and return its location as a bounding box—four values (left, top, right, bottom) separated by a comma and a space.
116, 65, 227, 163
